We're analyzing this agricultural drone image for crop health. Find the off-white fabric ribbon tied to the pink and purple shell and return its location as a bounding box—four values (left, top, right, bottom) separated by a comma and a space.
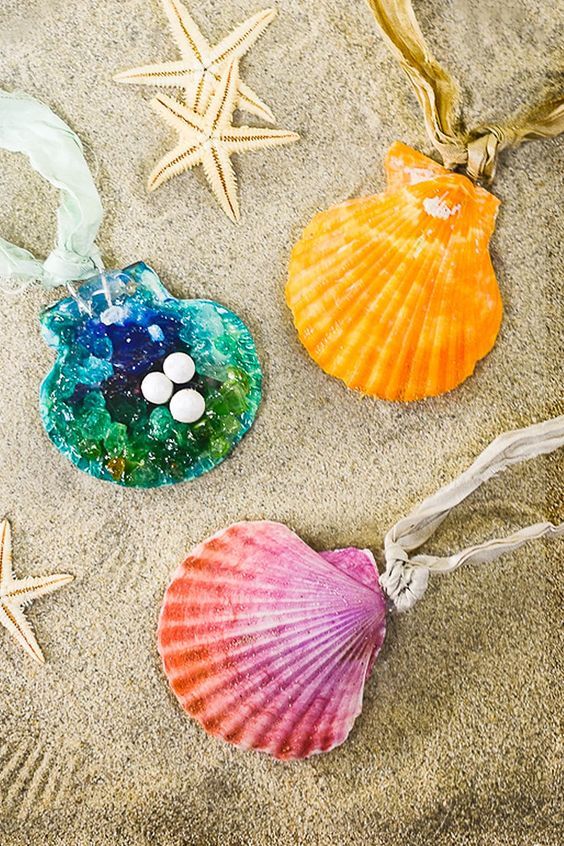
380, 416, 564, 611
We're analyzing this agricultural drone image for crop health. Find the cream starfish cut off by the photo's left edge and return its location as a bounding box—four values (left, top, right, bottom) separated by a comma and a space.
0, 520, 74, 664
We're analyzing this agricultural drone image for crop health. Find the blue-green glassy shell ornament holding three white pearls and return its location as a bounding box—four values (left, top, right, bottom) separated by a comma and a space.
40, 262, 262, 488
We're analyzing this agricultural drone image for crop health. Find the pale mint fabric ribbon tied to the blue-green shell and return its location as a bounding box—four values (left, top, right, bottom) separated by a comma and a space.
0, 91, 103, 288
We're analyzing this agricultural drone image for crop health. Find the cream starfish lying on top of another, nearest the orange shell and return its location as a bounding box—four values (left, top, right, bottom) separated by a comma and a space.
148, 61, 299, 222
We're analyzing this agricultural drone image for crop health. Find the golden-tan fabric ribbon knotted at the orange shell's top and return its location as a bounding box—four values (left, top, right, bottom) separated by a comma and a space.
368, 0, 564, 183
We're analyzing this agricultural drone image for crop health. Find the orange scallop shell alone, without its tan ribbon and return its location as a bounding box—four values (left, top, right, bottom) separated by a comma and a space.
286, 142, 502, 401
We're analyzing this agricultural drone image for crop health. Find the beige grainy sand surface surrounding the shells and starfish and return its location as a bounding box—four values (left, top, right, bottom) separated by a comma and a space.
0, 0, 564, 846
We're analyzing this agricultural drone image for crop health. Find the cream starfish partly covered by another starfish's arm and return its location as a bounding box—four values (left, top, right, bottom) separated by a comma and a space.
114, 0, 276, 123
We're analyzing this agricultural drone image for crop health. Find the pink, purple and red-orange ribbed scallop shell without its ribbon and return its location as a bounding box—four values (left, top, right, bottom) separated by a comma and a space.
158, 522, 386, 760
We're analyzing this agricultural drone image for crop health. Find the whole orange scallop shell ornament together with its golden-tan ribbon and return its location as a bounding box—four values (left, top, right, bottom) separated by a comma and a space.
286, 0, 564, 401
